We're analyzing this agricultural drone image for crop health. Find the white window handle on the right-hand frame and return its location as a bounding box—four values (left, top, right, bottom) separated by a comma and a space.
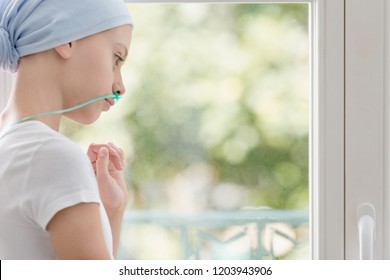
358, 203, 375, 260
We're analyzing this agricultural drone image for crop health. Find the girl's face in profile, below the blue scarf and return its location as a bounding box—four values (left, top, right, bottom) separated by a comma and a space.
63, 25, 132, 124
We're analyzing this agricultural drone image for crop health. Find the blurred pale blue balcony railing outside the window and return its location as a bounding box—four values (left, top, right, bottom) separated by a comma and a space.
120, 209, 309, 259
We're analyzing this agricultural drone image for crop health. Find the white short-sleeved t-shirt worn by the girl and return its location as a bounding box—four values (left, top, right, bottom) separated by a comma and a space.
0, 121, 112, 260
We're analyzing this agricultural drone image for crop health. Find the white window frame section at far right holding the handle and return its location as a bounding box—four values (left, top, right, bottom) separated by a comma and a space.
345, 0, 390, 259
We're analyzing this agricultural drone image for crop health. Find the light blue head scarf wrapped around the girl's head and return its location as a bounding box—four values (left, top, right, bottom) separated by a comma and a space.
0, 0, 133, 72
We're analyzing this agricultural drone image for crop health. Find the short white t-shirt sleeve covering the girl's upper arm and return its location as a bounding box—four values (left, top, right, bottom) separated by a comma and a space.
23, 139, 101, 230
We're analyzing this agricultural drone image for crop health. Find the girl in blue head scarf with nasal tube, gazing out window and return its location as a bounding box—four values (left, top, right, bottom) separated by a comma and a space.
0, 0, 133, 259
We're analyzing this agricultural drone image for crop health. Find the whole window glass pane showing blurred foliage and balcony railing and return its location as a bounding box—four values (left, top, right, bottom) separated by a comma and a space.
64, 3, 310, 259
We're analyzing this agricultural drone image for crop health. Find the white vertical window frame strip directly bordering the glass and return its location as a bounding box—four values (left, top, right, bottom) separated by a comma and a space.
310, 0, 345, 259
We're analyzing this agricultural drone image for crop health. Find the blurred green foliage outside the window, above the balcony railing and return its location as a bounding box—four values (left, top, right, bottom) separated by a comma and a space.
64, 3, 310, 211
